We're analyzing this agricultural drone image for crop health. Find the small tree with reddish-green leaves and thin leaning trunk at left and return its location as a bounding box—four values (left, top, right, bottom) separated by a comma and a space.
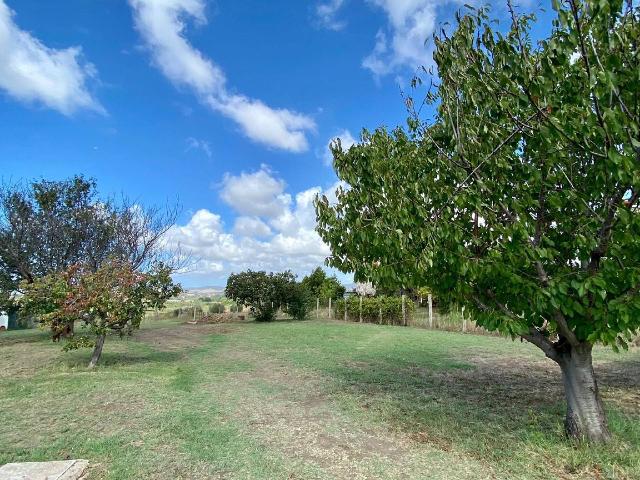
20, 261, 182, 368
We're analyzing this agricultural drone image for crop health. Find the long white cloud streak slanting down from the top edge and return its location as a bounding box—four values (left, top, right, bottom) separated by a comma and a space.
129, 0, 315, 152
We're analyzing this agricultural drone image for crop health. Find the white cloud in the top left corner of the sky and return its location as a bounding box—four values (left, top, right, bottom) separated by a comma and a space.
0, 0, 104, 115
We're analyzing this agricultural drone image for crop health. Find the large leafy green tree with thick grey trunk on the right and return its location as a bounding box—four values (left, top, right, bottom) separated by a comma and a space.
317, 0, 640, 442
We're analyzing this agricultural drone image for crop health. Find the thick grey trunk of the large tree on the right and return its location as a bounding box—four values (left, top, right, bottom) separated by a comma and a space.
558, 344, 611, 443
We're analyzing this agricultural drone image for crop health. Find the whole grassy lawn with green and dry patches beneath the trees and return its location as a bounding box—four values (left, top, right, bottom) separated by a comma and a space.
0, 319, 640, 479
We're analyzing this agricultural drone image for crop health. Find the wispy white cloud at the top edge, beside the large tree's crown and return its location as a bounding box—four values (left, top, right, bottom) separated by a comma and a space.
362, 0, 444, 75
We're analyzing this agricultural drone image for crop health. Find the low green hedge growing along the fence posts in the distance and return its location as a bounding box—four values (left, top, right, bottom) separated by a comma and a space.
336, 295, 415, 325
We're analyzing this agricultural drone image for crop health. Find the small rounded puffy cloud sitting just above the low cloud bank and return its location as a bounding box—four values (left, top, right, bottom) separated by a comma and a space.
220, 165, 291, 218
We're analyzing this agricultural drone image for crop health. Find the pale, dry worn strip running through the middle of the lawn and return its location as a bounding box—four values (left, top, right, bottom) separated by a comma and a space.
215, 350, 493, 480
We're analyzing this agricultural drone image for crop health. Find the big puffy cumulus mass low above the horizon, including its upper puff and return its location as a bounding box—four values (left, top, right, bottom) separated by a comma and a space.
168, 167, 340, 278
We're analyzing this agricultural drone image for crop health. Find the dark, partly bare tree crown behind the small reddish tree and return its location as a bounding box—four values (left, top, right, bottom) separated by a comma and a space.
0, 176, 179, 316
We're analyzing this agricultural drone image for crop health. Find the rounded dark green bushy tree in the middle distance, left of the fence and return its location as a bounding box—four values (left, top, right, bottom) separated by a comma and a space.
224, 270, 306, 322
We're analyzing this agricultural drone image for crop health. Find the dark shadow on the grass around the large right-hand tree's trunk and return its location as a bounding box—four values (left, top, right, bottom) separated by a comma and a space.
322, 346, 640, 478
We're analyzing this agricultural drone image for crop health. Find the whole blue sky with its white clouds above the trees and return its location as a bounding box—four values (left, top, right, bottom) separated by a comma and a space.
0, 0, 550, 287
